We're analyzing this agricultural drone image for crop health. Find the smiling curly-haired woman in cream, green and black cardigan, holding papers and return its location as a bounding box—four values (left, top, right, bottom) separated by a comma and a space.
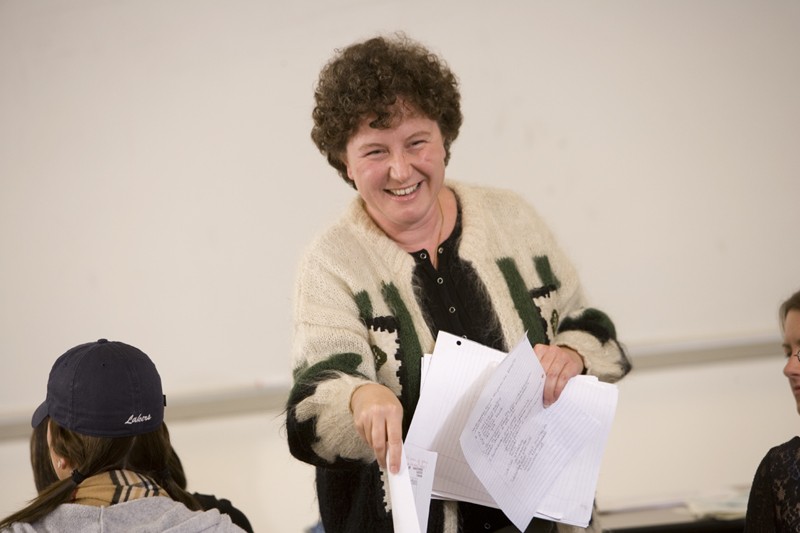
286, 34, 630, 533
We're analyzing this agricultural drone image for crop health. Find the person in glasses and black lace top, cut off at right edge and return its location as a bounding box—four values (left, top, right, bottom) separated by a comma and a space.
744, 291, 800, 533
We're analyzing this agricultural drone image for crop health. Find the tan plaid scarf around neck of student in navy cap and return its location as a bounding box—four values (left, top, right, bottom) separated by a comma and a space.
72, 470, 169, 507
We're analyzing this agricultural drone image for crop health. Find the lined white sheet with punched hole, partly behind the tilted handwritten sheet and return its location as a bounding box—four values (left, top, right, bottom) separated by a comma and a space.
405, 331, 506, 507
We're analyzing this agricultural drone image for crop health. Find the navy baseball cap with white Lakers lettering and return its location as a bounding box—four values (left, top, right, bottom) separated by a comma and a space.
31, 339, 166, 437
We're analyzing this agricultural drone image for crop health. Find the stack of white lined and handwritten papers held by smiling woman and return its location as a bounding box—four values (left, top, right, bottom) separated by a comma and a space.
390, 332, 617, 532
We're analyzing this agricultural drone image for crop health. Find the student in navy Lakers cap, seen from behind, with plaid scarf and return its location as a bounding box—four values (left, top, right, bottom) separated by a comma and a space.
0, 339, 242, 533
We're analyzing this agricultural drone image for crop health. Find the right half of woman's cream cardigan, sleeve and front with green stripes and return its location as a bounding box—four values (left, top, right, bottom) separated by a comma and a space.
457, 186, 631, 382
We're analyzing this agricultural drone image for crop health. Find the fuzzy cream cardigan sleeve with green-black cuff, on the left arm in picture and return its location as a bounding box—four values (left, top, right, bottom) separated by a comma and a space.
286, 245, 376, 467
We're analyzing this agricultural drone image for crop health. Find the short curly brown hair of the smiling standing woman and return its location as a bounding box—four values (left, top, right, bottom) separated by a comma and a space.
311, 33, 463, 187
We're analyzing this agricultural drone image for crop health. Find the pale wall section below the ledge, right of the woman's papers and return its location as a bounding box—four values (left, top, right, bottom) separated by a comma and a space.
597, 350, 800, 510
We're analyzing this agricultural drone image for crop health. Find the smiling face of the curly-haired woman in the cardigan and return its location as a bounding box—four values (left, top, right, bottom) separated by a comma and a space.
343, 107, 446, 240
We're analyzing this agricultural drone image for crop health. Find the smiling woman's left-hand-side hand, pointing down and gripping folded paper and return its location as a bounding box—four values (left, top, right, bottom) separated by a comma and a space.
350, 383, 403, 474
